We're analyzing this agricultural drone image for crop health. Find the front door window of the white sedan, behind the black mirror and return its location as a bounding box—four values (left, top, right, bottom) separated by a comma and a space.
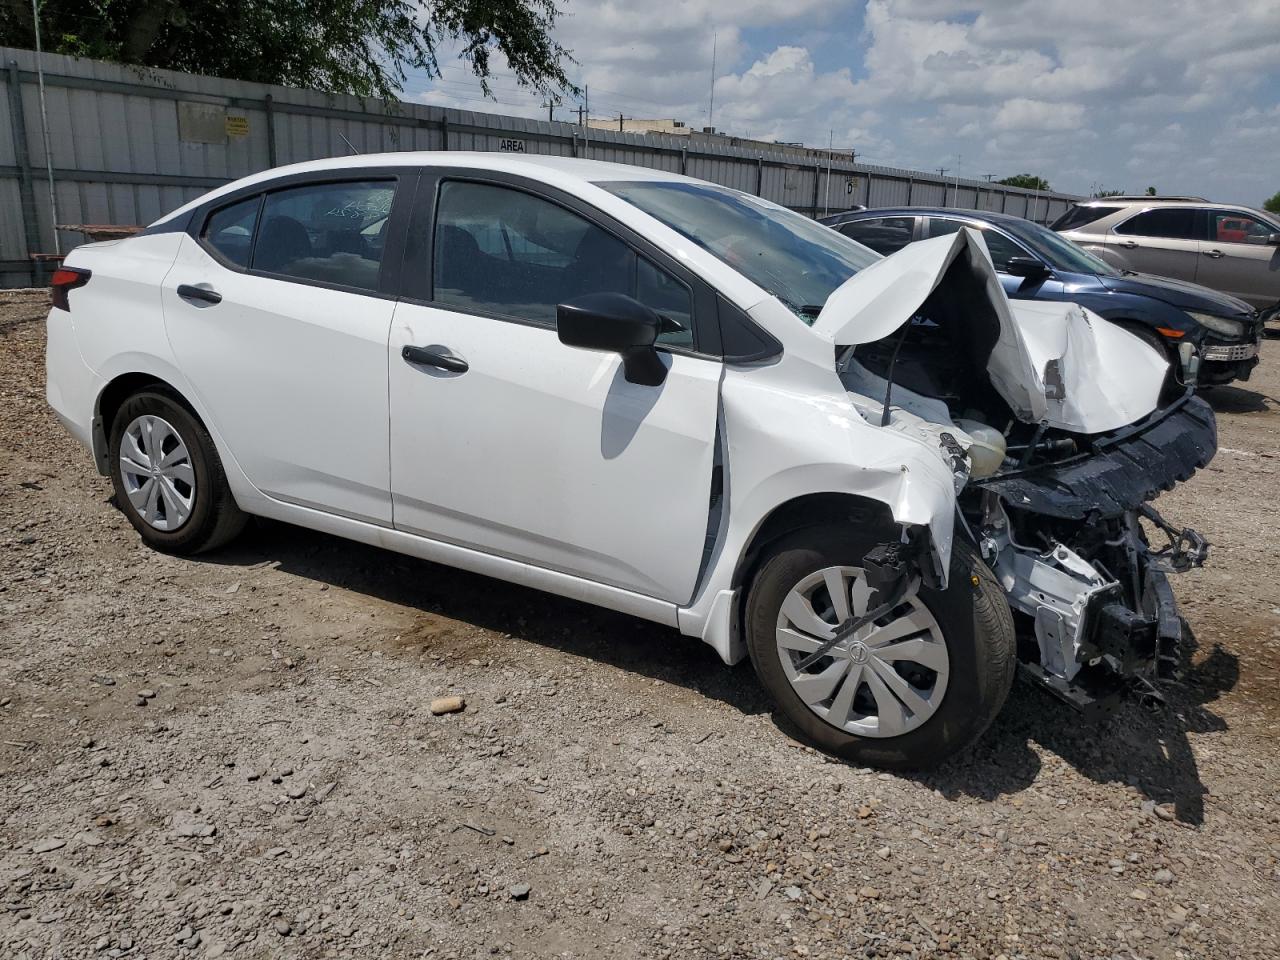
433, 180, 694, 347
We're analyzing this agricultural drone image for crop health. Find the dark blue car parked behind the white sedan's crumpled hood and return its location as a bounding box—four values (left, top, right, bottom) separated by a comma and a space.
823, 207, 1262, 384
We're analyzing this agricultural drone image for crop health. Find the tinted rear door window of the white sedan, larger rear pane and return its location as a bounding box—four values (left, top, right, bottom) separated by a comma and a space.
252, 180, 396, 291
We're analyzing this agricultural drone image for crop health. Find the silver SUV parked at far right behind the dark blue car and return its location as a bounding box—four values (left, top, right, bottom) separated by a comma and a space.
1053, 197, 1280, 320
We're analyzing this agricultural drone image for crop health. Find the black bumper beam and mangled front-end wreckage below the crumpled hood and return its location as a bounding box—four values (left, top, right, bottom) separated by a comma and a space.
973, 393, 1217, 710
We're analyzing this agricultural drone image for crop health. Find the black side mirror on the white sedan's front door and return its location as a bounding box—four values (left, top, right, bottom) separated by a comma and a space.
556, 293, 667, 387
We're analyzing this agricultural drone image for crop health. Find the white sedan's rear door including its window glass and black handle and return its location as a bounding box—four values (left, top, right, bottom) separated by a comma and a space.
161, 168, 416, 526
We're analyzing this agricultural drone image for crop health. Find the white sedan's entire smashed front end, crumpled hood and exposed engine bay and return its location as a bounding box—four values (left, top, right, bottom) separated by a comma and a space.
819, 230, 1217, 709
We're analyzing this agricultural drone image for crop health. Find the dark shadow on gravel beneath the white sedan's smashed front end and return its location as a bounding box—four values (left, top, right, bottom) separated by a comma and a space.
919, 628, 1239, 826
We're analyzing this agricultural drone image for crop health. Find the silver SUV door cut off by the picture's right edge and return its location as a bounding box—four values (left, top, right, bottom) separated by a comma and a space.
1196, 210, 1280, 307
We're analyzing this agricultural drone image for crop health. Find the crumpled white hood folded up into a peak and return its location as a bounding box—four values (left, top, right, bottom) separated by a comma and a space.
813, 228, 1169, 434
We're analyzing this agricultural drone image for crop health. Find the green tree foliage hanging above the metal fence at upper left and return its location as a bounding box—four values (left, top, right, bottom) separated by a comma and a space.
0, 0, 576, 99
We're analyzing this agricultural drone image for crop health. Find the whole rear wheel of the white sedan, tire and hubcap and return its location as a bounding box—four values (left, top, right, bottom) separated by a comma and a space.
109, 389, 246, 554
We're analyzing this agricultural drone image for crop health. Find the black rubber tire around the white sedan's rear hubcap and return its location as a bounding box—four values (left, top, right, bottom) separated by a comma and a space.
108, 388, 248, 556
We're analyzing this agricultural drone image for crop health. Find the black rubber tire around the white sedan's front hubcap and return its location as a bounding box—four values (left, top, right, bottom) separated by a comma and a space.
746, 524, 1016, 769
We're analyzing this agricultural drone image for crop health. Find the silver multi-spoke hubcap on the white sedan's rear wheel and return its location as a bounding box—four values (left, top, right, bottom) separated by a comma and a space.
120, 415, 196, 532
